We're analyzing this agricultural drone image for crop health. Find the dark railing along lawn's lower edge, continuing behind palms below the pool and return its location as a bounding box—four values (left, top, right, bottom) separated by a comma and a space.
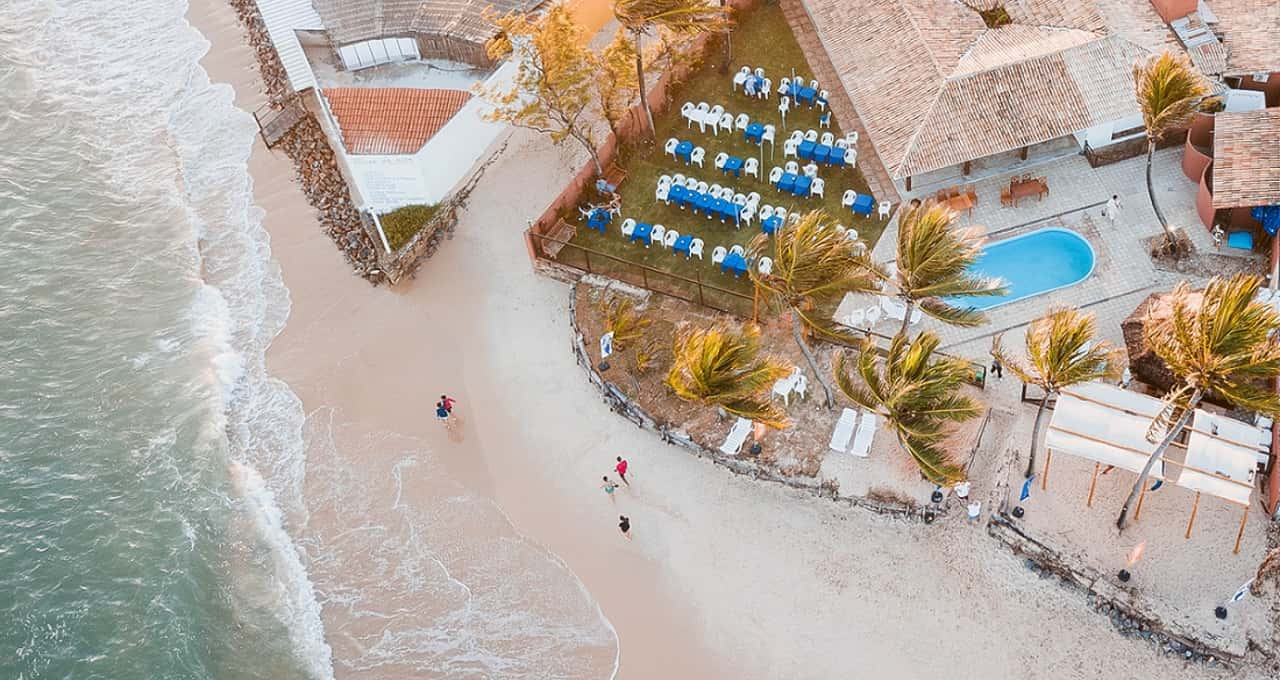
525, 229, 987, 388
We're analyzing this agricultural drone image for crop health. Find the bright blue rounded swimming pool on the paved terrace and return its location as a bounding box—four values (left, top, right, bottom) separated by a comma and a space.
948, 228, 1093, 310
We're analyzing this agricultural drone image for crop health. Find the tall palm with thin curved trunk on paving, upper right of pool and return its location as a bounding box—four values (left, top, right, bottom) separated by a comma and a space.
1133, 51, 1208, 248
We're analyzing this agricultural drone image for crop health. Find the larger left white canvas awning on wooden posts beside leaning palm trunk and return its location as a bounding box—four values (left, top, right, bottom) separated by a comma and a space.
1044, 383, 1165, 479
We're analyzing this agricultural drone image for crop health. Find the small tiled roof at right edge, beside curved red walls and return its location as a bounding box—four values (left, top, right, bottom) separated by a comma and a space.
1213, 109, 1280, 207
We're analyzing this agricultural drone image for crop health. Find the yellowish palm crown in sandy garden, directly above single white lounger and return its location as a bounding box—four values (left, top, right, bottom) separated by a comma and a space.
667, 325, 790, 429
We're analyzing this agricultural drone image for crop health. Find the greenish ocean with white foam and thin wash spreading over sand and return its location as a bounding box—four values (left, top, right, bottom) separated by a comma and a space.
0, 0, 618, 680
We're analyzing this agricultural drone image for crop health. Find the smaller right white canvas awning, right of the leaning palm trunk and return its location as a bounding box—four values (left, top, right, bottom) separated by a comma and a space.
1176, 410, 1261, 506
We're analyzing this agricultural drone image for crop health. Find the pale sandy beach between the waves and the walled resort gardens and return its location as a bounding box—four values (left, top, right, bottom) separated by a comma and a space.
192, 0, 1262, 679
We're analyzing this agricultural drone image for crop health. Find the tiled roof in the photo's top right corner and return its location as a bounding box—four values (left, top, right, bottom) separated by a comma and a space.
1207, 0, 1280, 76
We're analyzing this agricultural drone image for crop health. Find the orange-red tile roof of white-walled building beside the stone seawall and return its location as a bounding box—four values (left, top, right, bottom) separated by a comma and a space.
324, 87, 471, 154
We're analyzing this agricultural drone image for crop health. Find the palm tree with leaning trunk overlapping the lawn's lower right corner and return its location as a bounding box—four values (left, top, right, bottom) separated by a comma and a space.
750, 210, 878, 409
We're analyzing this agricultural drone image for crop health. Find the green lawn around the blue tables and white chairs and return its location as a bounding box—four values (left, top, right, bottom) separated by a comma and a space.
559, 4, 884, 295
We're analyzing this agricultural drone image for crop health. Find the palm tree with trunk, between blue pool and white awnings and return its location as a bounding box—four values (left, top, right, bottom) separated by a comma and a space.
991, 307, 1120, 478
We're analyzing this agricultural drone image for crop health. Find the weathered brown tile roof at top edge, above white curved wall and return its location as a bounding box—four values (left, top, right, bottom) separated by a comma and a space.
314, 0, 545, 45
